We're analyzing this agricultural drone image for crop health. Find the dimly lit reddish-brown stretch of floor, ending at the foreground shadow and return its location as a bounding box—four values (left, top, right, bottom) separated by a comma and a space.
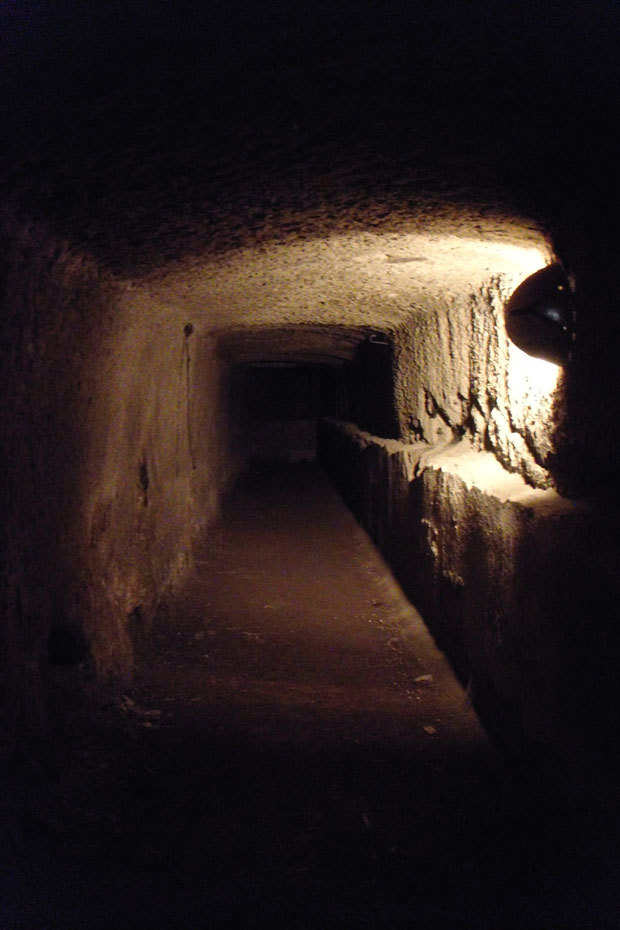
137, 462, 486, 759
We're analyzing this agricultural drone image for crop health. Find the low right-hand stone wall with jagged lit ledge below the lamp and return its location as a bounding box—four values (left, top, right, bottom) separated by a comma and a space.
319, 421, 620, 803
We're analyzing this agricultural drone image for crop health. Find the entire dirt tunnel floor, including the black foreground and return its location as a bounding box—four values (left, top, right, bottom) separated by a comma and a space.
0, 465, 620, 930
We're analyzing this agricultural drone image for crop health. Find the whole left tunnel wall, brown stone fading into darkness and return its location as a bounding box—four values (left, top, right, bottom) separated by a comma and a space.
0, 216, 241, 732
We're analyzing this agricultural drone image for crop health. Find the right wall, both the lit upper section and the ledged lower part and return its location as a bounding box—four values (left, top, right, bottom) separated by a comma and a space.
319, 270, 620, 792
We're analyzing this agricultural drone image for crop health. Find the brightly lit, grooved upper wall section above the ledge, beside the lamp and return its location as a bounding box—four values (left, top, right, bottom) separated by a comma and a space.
395, 277, 557, 487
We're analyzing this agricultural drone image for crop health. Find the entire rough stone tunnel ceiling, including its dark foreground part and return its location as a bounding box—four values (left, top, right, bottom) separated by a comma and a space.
0, 0, 618, 330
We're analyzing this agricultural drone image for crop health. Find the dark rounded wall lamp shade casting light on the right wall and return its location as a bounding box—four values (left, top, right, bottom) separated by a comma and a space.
504, 263, 575, 365
